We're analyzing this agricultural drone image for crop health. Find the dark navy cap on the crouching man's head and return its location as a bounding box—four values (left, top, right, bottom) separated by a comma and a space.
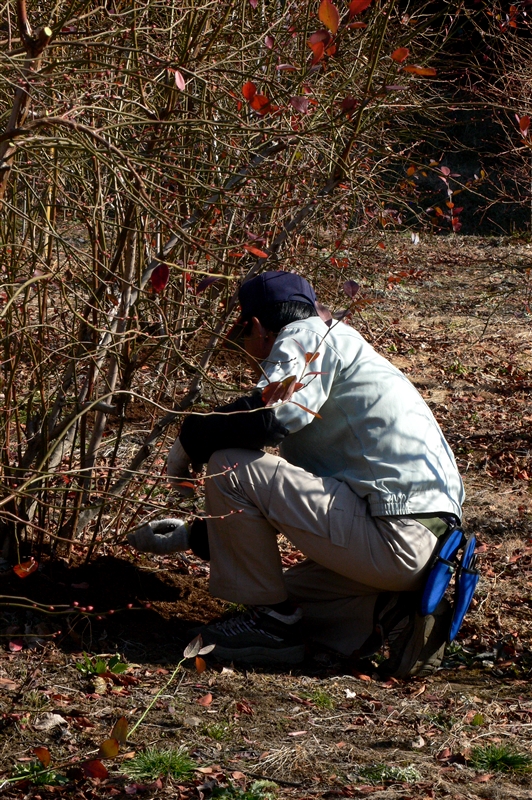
238, 271, 316, 320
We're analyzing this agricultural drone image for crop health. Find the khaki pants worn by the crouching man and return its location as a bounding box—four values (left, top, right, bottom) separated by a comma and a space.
205, 449, 437, 654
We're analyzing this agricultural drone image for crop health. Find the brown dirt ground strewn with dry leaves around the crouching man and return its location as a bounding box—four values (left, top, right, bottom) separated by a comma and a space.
0, 237, 532, 800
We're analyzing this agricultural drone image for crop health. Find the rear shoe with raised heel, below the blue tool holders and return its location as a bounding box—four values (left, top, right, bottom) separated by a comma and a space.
379, 598, 452, 678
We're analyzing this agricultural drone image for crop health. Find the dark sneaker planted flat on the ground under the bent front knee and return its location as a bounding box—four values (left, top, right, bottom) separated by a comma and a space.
198, 606, 305, 664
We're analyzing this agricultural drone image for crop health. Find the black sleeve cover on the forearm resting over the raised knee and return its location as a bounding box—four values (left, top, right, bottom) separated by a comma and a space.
179, 391, 289, 464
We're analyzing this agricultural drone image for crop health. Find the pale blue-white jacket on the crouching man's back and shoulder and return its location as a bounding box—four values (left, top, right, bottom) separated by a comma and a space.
258, 317, 464, 518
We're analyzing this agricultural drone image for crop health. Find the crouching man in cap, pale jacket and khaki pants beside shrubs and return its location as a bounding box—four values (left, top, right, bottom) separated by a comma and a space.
130, 272, 464, 677
